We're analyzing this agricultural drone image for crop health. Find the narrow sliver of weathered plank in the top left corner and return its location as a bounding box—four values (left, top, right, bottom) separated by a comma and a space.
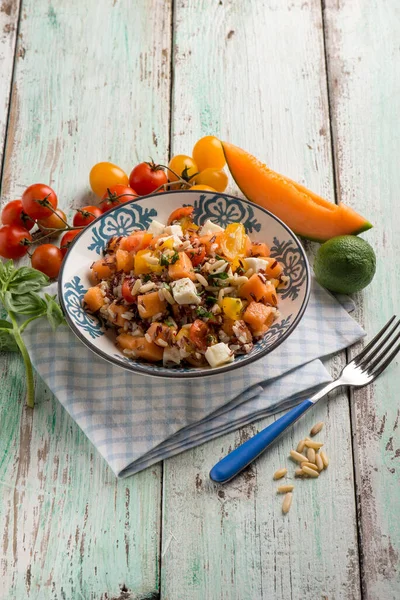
0, 0, 20, 172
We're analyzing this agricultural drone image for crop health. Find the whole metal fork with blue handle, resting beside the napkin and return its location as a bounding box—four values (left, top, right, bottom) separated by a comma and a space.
210, 316, 400, 483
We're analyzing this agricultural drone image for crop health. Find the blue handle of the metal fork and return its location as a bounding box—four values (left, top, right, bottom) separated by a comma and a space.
210, 400, 314, 483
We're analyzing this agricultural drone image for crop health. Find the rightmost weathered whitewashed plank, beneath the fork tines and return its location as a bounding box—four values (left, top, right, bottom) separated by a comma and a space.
325, 0, 400, 600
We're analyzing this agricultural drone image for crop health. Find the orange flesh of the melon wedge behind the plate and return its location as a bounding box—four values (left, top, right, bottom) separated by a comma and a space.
221, 142, 372, 242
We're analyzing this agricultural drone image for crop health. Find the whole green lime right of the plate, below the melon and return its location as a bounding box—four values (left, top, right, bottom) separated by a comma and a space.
314, 235, 376, 294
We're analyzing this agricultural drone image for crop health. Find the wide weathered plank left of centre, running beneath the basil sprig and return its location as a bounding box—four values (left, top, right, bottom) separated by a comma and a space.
0, 0, 171, 600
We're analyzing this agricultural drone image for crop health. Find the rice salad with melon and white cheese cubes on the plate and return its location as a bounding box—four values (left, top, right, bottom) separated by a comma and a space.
84, 206, 288, 368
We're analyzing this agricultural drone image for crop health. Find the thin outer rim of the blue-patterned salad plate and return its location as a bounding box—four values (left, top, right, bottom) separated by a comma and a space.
58, 190, 311, 379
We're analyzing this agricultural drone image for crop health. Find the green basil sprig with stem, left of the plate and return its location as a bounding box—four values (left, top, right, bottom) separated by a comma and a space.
0, 260, 66, 408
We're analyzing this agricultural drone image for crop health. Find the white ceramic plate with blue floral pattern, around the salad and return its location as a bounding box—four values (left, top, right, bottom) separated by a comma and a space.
59, 190, 310, 378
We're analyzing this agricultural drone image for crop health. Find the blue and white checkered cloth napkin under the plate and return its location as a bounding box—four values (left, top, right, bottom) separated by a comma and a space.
25, 282, 364, 477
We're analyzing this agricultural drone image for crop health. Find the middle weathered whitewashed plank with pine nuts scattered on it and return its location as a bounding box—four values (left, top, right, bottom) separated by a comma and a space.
161, 0, 360, 600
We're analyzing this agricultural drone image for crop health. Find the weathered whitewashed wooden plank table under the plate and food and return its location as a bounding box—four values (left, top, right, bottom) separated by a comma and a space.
0, 0, 400, 600
